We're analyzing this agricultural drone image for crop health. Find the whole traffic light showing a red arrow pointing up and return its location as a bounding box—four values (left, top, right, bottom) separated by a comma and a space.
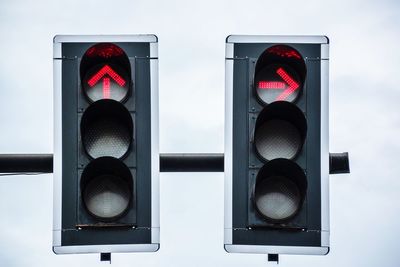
53, 35, 159, 254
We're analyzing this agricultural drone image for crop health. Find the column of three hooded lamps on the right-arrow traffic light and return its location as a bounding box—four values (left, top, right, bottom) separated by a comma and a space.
252, 45, 307, 225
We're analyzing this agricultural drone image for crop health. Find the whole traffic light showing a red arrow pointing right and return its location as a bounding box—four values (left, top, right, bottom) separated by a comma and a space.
224, 36, 329, 255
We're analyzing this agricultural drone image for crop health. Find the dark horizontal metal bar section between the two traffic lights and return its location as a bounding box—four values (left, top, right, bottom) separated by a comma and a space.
160, 153, 224, 172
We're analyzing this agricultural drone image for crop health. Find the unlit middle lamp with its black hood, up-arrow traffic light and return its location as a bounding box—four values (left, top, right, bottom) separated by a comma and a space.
81, 100, 133, 158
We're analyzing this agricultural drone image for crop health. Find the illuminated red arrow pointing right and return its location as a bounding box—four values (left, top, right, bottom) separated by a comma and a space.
258, 68, 299, 100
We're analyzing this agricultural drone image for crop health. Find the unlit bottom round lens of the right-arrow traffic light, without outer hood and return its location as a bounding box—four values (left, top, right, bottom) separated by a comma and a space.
255, 176, 301, 220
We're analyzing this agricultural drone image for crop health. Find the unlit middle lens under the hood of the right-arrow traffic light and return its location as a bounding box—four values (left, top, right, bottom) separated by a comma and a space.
255, 120, 302, 160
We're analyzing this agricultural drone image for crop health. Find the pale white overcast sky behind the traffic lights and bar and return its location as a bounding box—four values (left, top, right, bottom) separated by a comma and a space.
0, 0, 400, 267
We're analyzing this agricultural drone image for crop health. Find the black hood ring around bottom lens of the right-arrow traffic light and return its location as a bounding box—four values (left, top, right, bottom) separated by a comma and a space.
251, 158, 308, 224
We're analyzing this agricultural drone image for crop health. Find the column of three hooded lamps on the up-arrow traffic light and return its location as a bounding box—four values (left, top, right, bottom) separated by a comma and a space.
80, 43, 134, 224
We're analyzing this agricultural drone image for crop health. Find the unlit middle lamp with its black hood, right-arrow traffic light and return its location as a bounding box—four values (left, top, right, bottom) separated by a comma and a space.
254, 101, 307, 161
